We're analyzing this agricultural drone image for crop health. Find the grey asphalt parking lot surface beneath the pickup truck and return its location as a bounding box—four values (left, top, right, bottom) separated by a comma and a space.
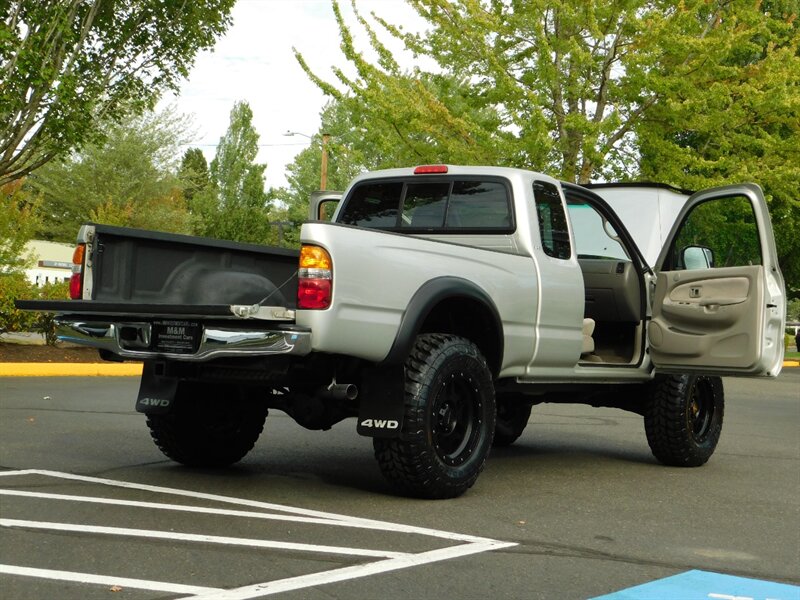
0, 368, 800, 600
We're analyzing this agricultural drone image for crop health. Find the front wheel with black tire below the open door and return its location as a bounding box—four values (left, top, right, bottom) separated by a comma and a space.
644, 375, 725, 467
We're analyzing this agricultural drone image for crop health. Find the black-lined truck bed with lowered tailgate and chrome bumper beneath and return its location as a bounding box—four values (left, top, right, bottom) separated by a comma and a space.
16, 224, 310, 360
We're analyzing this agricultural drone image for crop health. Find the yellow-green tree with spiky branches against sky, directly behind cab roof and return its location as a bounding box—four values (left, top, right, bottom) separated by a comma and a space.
298, 0, 708, 182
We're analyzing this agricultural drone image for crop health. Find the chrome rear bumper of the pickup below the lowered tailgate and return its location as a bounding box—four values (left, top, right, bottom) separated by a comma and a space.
56, 318, 311, 362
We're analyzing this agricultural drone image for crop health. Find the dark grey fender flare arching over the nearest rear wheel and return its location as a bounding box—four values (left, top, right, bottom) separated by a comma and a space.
381, 276, 503, 374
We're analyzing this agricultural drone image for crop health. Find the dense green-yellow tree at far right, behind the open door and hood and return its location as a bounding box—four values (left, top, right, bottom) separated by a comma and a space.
637, 0, 800, 298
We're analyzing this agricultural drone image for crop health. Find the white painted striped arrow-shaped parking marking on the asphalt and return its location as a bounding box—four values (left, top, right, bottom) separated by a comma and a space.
0, 469, 516, 600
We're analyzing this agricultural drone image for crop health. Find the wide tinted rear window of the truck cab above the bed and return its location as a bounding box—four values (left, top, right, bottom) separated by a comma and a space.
338, 179, 513, 233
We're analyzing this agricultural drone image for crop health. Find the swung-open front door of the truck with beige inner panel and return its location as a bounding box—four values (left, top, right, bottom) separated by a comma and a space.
648, 184, 786, 377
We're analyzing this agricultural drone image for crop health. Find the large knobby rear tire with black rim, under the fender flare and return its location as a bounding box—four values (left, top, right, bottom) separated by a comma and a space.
373, 334, 495, 499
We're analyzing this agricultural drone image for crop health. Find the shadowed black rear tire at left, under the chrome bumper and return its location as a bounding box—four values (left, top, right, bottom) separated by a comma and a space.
147, 382, 268, 467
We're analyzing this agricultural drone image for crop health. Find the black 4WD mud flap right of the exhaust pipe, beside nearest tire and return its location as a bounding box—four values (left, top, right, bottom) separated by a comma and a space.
357, 365, 405, 438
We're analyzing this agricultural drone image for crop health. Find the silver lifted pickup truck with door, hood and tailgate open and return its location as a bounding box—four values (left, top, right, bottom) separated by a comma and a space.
18, 165, 785, 498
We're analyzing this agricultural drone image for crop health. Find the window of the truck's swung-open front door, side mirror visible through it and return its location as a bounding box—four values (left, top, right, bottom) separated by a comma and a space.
668, 197, 762, 270
